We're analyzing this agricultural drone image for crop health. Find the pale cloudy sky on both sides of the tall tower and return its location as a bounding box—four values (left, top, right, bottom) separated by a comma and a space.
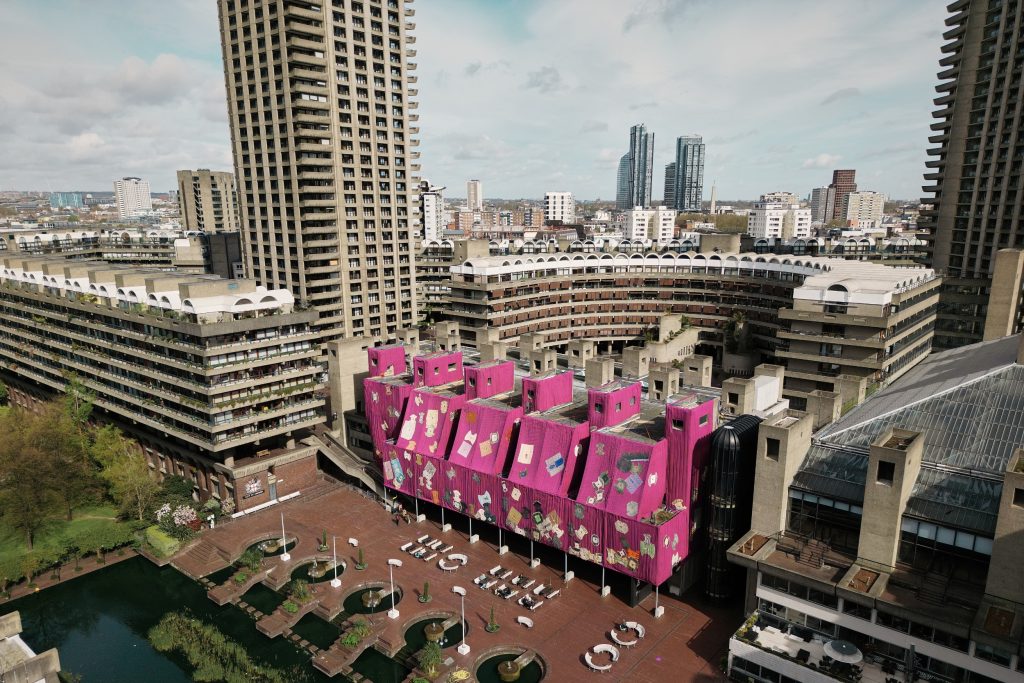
0, 0, 945, 199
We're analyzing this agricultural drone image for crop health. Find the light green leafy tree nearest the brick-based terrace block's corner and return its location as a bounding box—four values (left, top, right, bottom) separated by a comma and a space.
90, 425, 160, 521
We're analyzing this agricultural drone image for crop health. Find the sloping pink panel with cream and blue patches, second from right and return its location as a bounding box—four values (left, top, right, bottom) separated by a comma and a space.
509, 415, 590, 496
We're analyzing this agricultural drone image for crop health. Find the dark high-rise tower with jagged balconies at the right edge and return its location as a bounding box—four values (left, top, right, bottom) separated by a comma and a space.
919, 0, 1024, 348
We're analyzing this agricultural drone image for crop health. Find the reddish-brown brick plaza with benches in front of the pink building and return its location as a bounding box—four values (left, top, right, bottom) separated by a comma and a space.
173, 484, 741, 683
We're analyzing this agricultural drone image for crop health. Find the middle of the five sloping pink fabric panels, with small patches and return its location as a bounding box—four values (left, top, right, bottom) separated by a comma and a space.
449, 399, 522, 474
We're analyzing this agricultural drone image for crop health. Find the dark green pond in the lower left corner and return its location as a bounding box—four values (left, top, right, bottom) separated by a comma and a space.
0, 557, 409, 683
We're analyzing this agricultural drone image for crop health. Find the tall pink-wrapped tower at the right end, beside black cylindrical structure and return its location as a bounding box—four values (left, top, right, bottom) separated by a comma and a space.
665, 394, 718, 509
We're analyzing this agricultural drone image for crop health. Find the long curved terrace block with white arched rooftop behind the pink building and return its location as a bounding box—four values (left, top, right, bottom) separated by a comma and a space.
444, 252, 939, 408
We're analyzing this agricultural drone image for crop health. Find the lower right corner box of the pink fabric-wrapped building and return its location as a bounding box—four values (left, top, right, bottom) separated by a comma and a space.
604, 510, 689, 584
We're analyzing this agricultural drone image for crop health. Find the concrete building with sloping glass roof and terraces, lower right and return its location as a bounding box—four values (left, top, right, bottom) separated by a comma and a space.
728, 336, 1024, 683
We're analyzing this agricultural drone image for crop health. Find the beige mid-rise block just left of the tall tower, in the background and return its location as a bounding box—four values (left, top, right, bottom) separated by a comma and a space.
177, 168, 241, 232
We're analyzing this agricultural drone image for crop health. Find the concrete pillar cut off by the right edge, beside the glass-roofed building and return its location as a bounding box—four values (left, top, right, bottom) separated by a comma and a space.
985, 449, 1024, 603
